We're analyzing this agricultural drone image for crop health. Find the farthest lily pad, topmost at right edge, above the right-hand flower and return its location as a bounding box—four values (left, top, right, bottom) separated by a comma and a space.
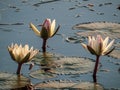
73, 22, 120, 33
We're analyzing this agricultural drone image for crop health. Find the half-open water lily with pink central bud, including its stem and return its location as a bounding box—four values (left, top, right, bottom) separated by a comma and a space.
30, 18, 60, 52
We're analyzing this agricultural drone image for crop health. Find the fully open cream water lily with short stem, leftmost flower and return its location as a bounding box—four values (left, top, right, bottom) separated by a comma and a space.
8, 43, 38, 74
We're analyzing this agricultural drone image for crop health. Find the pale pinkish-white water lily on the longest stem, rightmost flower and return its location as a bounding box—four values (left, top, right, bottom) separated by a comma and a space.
81, 35, 114, 81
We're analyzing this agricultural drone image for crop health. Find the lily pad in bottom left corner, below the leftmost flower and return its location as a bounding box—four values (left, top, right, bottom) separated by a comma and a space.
0, 72, 30, 90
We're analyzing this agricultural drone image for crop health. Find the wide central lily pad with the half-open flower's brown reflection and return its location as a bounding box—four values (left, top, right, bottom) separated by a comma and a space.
34, 52, 95, 74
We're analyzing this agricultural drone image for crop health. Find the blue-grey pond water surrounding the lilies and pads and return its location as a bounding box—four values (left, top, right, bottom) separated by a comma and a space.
0, 0, 120, 90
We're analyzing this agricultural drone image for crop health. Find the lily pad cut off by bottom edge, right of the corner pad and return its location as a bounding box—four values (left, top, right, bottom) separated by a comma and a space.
36, 81, 104, 90
